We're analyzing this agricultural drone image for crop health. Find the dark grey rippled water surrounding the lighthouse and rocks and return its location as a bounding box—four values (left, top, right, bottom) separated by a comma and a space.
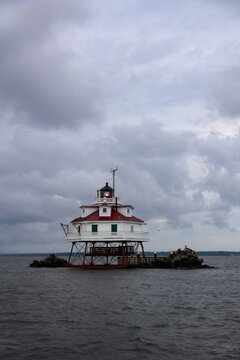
0, 256, 240, 360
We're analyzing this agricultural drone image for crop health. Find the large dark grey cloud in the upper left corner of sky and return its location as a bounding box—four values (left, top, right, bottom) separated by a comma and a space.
0, 1, 102, 127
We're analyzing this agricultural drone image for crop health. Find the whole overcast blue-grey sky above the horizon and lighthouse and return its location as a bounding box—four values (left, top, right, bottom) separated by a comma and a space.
0, 0, 240, 253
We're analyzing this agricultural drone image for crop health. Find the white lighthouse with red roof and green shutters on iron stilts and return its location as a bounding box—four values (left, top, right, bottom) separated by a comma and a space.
61, 169, 149, 269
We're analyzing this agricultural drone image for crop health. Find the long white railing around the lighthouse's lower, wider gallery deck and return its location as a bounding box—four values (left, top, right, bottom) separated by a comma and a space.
66, 231, 149, 241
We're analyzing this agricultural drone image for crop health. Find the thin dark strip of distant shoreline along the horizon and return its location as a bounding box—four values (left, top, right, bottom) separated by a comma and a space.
0, 251, 240, 257
